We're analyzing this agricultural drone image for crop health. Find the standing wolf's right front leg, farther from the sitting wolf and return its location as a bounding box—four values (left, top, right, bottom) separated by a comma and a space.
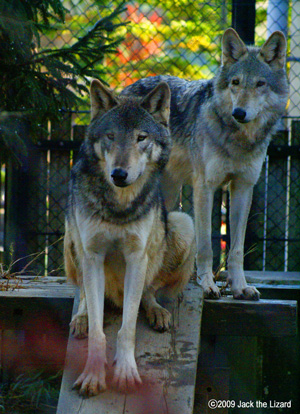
227, 180, 260, 300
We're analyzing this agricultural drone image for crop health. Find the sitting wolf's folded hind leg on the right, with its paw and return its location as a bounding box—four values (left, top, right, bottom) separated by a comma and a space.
142, 212, 195, 332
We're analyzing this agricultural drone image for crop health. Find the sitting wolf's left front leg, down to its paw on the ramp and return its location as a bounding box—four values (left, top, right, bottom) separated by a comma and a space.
74, 255, 106, 396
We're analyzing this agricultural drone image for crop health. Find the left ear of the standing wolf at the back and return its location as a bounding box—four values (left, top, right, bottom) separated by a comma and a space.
222, 28, 248, 65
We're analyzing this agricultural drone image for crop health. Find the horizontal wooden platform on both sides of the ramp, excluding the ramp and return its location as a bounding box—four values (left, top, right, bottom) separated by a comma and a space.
0, 272, 300, 337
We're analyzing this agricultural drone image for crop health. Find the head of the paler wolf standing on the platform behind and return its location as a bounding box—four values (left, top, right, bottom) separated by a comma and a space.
216, 28, 288, 124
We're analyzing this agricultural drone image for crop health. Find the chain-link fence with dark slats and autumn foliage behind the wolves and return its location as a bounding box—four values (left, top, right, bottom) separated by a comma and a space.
0, 0, 300, 273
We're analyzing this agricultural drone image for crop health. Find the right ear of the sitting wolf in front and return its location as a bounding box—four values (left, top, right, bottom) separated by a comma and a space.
142, 82, 171, 126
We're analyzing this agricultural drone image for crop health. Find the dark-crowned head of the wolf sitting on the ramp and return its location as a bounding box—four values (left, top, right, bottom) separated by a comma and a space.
87, 80, 171, 187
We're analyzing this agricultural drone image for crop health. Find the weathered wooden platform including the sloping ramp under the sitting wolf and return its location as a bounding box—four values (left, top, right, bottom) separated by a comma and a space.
0, 272, 300, 414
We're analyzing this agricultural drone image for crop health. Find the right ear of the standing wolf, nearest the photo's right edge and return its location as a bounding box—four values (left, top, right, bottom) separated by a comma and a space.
258, 31, 286, 69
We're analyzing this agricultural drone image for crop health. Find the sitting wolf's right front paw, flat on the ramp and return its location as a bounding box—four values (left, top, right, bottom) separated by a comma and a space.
113, 356, 142, 392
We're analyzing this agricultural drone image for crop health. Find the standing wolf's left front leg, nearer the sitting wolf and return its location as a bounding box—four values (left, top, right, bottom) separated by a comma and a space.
193, 179, 220, 299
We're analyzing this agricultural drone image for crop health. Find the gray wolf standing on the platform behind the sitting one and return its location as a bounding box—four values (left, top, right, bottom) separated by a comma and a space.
123, 29, 288, 300
